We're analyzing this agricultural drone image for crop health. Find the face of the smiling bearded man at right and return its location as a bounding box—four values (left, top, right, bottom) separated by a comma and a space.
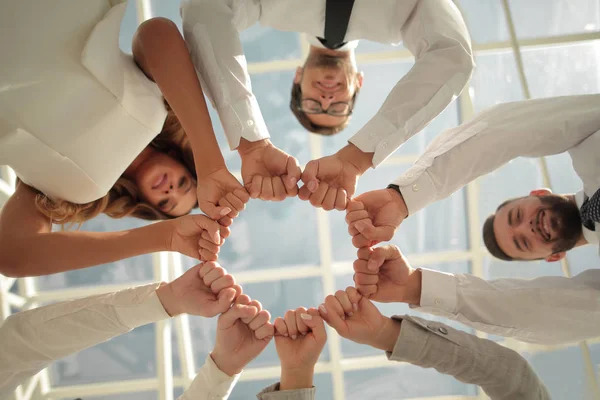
494, 191, 582, 261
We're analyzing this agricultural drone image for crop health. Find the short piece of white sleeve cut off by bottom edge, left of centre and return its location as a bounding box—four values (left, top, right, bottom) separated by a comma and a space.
178, 354, 241, 400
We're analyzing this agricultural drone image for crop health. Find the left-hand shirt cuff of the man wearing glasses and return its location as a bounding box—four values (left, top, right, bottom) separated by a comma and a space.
217, 95, 270, 150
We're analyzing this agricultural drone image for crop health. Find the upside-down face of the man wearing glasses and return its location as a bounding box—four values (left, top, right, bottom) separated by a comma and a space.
294, 55, 362, 126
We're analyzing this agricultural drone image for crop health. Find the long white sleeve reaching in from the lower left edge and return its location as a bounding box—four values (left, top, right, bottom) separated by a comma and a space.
0, 284, 169, 398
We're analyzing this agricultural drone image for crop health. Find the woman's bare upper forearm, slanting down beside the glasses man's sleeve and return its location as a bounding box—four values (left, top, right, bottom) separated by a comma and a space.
136, 19, 225, 176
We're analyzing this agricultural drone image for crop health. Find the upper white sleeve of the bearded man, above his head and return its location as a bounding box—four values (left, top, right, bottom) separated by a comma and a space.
393, 95, 600, 214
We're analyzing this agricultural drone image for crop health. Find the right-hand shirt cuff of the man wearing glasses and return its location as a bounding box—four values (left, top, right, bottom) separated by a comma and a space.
349, 115, 406, 168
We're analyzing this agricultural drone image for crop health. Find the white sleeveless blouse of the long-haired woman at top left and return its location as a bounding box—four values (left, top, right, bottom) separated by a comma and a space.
0, 0, 167, 203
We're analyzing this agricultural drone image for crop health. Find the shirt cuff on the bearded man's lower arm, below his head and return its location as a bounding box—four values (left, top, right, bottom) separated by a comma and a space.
420, 268, 457, 314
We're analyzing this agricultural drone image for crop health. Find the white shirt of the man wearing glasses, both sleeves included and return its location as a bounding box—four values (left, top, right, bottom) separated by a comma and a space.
182, 0, 473, 167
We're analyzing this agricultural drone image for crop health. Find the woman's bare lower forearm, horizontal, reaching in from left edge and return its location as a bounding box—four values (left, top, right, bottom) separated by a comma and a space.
0, 222, 170, 277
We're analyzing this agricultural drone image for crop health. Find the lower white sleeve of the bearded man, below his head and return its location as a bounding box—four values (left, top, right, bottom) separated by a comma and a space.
413, 269, 600, 345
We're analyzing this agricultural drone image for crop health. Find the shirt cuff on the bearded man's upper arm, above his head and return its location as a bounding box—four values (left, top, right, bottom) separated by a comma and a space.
392, 165, 437, 215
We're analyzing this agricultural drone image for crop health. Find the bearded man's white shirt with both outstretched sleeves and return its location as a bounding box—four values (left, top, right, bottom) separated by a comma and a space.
394, 95, 600, 344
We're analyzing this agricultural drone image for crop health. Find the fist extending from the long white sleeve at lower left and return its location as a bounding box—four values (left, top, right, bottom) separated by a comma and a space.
156, 262, 242, 318
